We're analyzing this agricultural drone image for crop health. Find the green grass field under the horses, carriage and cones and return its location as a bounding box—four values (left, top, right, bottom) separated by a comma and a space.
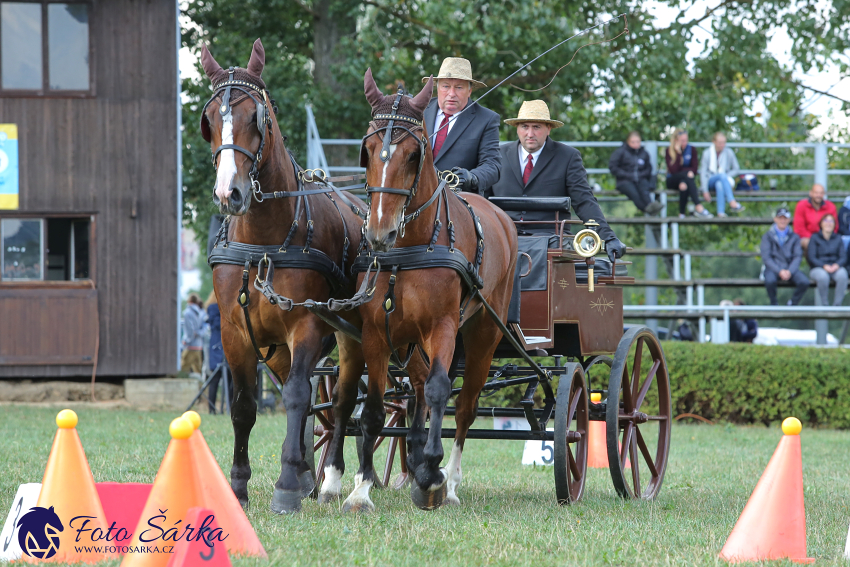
0, 406, 850, 566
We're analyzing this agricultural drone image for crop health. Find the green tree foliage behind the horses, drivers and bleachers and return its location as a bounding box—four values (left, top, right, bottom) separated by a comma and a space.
183, 0, 850, 247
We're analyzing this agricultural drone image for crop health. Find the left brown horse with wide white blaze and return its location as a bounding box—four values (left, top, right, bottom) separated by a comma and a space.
201, 39, 363, 513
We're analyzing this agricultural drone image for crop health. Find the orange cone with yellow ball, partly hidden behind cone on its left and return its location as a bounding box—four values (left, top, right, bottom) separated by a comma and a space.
183, 411, 267, 557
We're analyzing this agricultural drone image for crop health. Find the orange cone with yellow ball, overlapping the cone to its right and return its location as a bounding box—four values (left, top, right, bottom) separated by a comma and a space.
121, 417, 201, 567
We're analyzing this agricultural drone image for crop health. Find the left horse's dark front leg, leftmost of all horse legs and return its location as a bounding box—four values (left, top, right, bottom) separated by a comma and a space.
227, 344, 264, 508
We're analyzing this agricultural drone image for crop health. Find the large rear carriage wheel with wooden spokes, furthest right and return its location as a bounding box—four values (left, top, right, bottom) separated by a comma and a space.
605, 326, 672, 499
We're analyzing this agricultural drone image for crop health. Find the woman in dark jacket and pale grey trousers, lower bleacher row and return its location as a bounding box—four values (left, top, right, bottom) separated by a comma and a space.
806, 214, 847, 306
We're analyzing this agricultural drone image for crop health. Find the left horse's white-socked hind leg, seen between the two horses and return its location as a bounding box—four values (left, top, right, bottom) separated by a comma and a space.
319, 333, 366, 504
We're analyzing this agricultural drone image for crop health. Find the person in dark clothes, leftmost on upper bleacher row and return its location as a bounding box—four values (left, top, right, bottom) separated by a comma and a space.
608, 131, 664, 215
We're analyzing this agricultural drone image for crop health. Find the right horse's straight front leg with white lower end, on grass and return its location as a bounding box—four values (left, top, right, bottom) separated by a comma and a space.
342, 345, 389, 512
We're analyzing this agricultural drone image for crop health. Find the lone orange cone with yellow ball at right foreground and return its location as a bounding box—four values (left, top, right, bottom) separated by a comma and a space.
720, 417, 814, 563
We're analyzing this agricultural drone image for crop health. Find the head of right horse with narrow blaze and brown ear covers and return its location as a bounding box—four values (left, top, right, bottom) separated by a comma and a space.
360, 69, 434, 252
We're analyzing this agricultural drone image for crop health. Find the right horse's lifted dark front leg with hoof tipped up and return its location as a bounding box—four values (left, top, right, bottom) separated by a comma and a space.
410, 321, 457, 510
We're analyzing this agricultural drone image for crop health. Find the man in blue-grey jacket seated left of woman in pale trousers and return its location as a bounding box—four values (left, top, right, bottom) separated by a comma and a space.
760, 207, 809, 305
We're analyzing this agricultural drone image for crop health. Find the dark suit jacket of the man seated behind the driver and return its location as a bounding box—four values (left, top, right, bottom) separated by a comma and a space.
485, 138, 616, 242
